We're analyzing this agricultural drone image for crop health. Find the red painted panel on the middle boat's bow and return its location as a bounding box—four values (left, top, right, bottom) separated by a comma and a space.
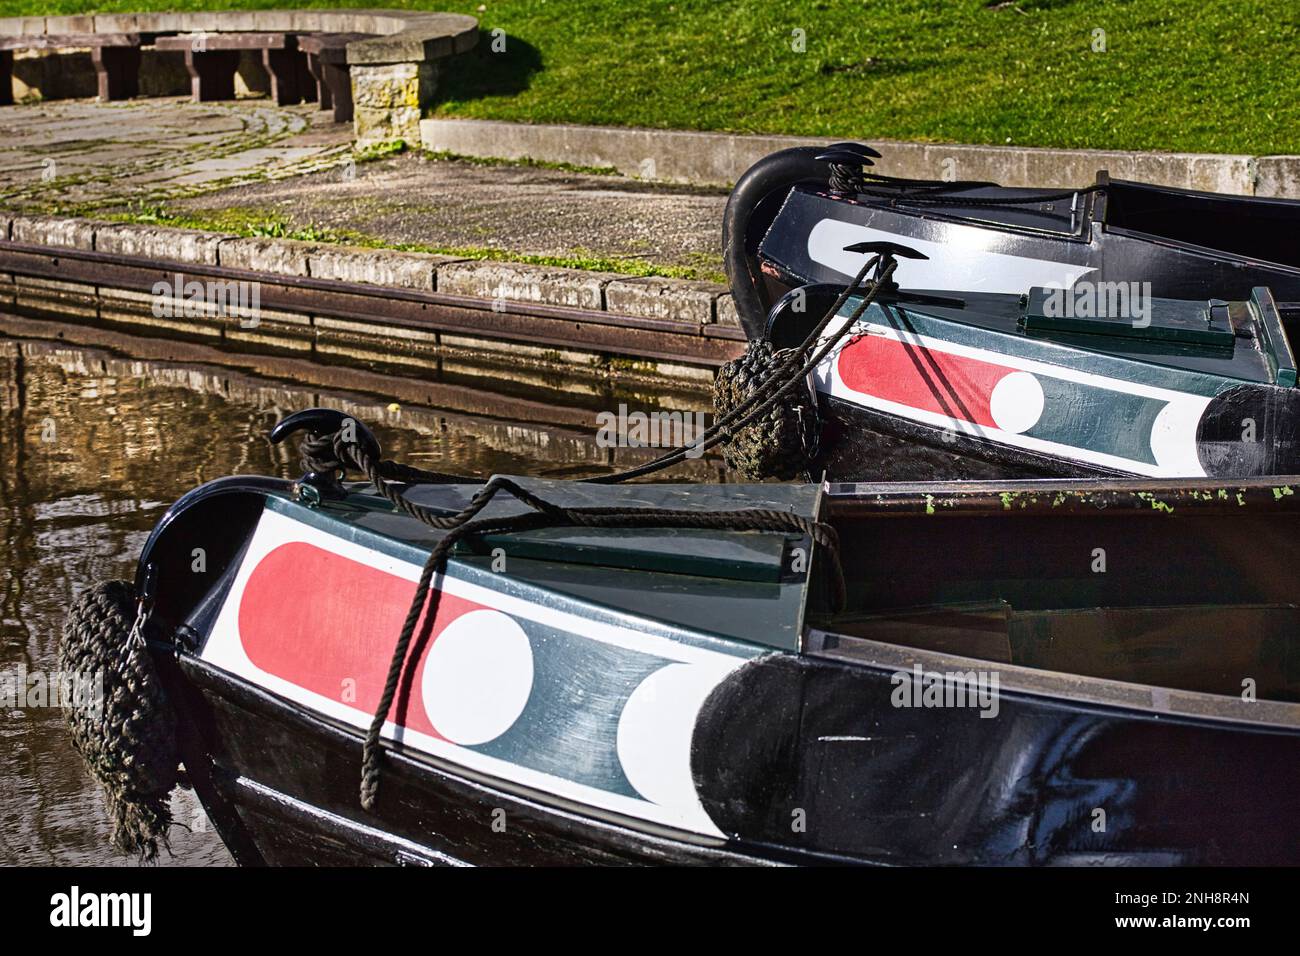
837, 336, 1017, 428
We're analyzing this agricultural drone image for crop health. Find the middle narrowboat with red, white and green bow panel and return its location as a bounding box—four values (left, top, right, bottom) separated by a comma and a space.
767, 265, 1300, 480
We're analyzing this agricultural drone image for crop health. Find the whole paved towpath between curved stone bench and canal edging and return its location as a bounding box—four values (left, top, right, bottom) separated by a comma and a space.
0, 98, 725, 277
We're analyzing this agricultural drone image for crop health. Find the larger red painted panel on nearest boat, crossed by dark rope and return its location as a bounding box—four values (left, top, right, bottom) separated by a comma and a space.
239, 541, 482, 736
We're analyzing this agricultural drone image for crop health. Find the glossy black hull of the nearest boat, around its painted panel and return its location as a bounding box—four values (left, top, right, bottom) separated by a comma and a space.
157, 634, 1300, 865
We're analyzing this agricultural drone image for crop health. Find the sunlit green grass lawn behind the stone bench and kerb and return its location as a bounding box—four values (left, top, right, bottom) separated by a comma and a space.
0, 0, 1300, 153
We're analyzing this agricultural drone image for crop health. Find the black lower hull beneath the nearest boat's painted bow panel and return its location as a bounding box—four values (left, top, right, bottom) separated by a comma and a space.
155, 648, 763, 866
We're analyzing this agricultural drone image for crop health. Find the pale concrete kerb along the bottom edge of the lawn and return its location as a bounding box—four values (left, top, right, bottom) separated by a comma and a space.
420, 117, 1300, 196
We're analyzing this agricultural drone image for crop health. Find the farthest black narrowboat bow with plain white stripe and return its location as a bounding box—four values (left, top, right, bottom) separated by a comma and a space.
723, 143, 1300, 338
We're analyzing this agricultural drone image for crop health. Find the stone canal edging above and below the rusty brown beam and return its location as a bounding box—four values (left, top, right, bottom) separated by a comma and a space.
0, 213, 740, 381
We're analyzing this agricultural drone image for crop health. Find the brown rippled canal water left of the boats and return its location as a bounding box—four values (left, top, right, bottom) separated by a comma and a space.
0, 317, 720, 865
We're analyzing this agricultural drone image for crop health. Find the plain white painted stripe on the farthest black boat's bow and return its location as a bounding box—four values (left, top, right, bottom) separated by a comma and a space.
809, 219, 1096, 295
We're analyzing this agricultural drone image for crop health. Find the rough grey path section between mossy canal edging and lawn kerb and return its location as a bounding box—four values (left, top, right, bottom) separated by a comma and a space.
176, 153, 727, 276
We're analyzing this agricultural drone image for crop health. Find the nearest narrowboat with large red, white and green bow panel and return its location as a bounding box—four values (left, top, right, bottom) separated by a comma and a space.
66, 412, 1300, 864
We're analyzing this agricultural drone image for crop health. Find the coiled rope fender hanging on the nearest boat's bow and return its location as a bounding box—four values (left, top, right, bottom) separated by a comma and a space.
59, 581, 179, 861
